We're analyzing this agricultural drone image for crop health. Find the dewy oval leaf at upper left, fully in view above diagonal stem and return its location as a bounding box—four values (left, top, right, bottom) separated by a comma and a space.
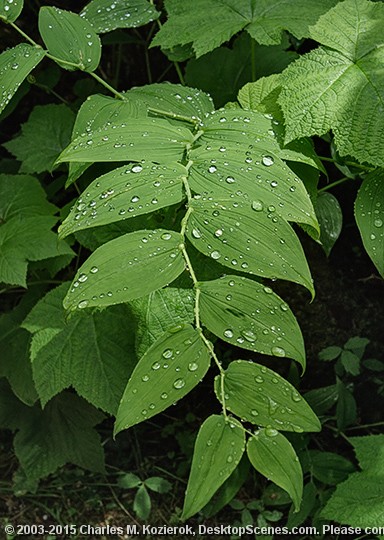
39, 6, 101, 72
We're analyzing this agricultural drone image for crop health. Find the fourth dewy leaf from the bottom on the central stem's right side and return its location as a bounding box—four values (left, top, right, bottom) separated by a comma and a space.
187, 196, 313, 294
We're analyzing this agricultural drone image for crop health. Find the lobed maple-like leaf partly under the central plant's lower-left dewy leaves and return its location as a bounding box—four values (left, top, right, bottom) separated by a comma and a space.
23, 283, 136, 414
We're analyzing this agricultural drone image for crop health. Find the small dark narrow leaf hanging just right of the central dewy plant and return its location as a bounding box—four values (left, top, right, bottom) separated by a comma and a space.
315, 191, 343, 255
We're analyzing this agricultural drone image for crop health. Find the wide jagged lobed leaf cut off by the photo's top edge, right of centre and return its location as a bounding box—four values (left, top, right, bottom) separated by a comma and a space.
152, 0, 336, 57
